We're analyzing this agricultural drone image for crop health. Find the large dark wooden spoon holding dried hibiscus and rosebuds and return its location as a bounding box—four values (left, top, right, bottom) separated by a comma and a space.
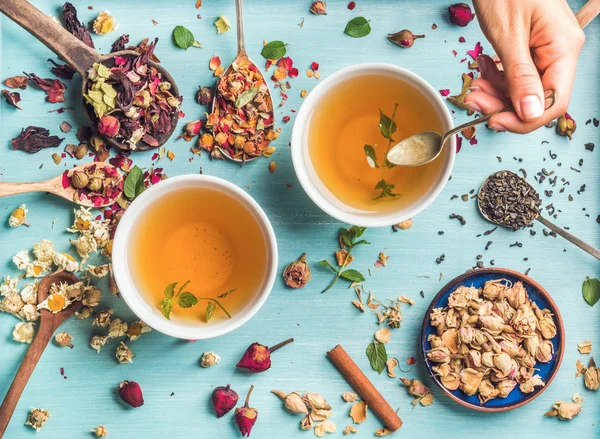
0, 0, 179, 151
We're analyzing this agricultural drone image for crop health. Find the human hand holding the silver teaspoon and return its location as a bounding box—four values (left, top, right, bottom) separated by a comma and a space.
465, 0, 585, 134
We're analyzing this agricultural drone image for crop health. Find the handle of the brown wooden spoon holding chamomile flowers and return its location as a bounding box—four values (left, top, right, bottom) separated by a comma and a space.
0, 324, 54, 438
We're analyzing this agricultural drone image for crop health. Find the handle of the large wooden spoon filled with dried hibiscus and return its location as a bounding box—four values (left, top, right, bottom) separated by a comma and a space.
0, 0, 100, 75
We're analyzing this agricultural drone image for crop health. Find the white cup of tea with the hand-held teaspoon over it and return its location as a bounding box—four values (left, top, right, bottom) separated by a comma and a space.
291, 63, 456, 227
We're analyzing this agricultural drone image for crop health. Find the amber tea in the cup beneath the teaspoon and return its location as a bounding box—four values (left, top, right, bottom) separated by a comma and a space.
308, 74, 444, 212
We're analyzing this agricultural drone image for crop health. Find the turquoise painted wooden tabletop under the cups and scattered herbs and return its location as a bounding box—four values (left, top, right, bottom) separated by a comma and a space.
0, 0, 600, 439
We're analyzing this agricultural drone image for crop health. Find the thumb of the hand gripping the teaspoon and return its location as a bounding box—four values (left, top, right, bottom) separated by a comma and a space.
501, 40, 544, 122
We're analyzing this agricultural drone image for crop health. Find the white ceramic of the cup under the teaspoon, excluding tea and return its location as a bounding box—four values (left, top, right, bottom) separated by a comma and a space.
291, 63, 456, 227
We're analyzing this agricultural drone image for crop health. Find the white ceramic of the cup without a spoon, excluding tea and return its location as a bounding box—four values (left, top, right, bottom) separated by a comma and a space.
112, 175, 277, 340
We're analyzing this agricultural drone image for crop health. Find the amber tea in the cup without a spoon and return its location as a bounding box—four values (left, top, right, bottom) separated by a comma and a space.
129, 188, 267, 323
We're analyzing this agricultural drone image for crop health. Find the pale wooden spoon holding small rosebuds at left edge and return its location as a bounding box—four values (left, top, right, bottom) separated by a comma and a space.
0, 162, 123, 207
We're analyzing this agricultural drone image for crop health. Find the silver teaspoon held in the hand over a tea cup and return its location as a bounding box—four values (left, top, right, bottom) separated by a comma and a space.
387, 90, 556, 166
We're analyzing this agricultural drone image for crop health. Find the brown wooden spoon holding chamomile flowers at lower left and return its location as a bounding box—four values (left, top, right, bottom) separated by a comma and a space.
0, 271, 81, 438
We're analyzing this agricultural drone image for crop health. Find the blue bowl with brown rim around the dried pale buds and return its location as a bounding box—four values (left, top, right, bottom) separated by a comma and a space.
421, 268, 565, 412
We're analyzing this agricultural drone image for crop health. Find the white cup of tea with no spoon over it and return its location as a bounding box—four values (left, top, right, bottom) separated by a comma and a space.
112, 175, 277, 340
